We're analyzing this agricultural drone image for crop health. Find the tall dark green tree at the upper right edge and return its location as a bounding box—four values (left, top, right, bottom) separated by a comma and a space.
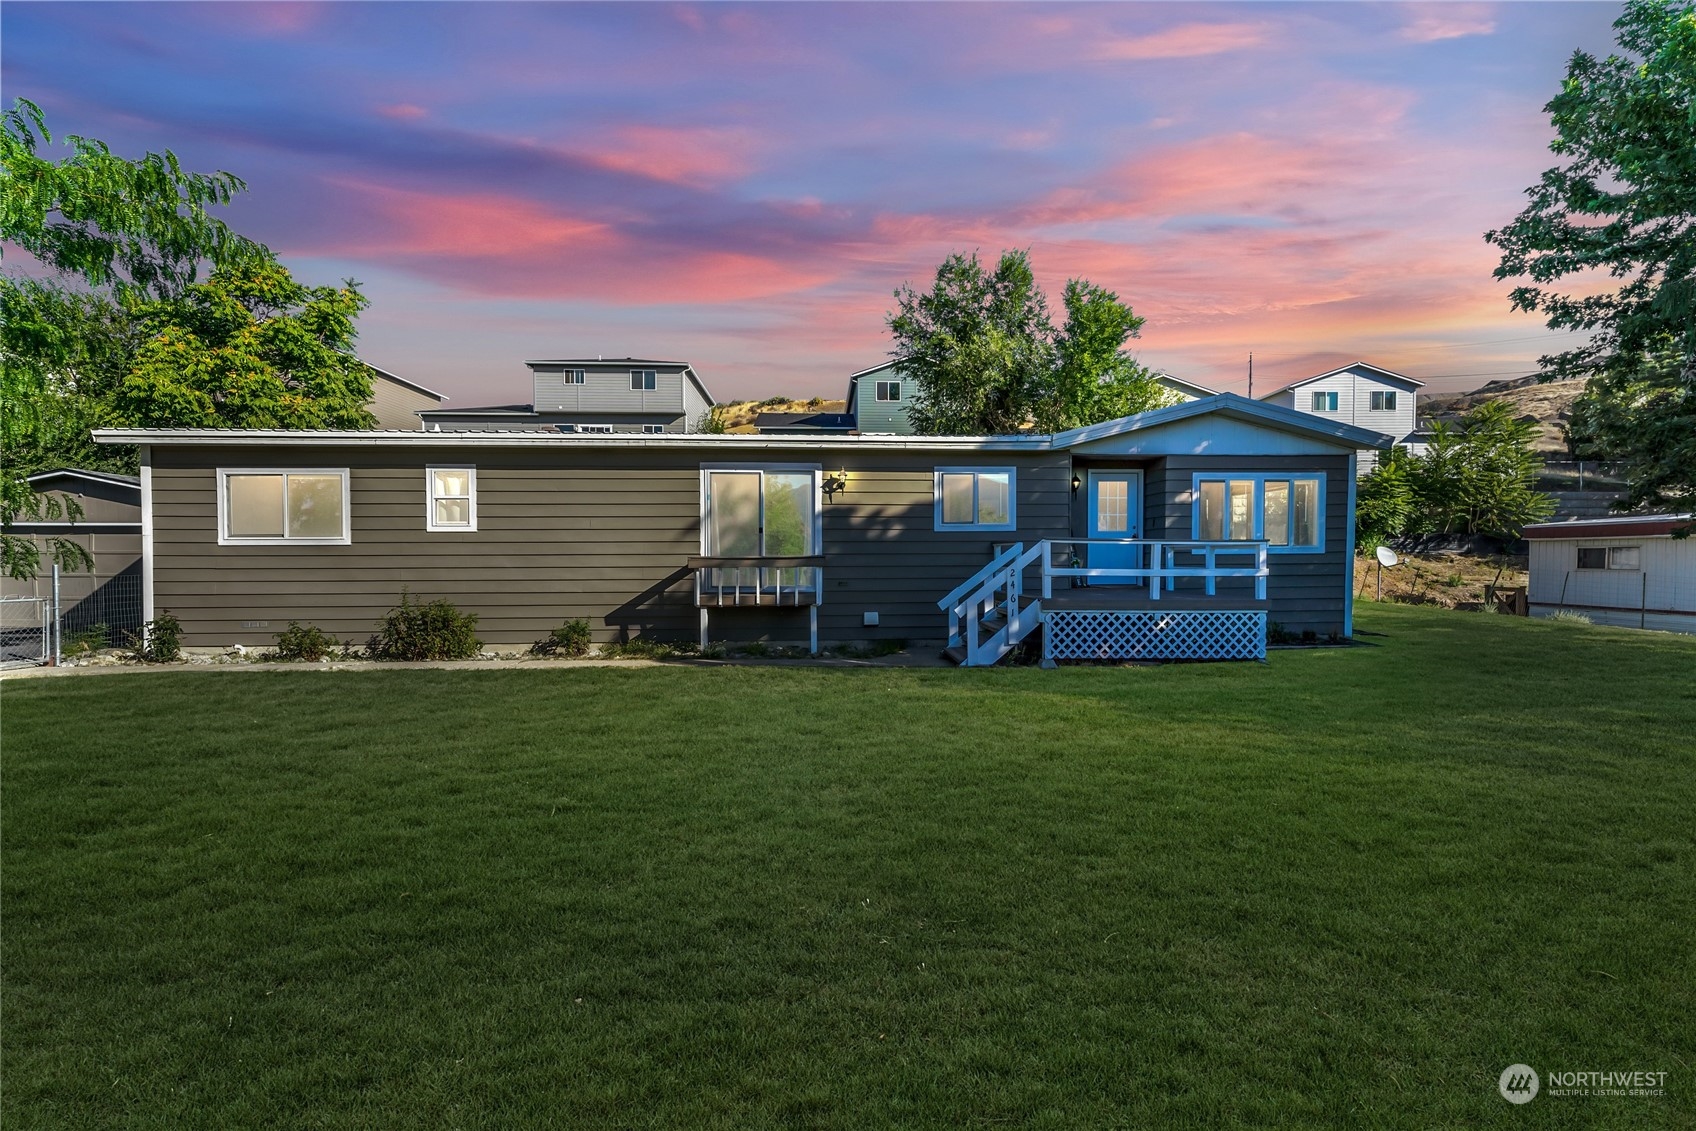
1486, 0, 1696, 522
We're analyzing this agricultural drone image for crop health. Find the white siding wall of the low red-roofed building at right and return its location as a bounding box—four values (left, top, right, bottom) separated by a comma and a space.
1530, 534, 1696, 612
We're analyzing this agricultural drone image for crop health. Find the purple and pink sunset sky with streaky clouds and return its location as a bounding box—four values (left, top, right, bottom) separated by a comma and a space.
0, 0, 1620, 405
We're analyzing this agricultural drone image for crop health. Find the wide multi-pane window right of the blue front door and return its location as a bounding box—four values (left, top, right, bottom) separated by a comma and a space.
1191, 471, 1325, 554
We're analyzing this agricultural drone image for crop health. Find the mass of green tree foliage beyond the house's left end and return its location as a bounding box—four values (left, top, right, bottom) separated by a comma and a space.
0, 100, 370, 578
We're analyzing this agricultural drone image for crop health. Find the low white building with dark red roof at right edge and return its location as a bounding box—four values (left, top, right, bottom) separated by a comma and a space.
1525, 514, 1696, 632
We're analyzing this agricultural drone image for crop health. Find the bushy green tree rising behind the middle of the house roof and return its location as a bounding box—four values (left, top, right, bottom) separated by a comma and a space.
889, 251, 1170, 436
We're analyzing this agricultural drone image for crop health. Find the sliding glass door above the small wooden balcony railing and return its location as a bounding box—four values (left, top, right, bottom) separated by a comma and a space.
702, 468, 819, 592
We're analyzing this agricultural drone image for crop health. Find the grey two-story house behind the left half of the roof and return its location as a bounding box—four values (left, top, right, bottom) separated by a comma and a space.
419, 358, 712, 432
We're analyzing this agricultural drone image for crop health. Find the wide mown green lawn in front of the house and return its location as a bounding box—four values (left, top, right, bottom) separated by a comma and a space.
0, 605, 1696, 1131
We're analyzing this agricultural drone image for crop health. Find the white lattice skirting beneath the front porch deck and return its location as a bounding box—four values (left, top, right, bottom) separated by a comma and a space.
1045, 610, 1267, 660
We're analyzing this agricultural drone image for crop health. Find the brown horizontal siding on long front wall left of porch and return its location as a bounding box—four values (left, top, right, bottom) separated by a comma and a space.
153, 444, 1070, 646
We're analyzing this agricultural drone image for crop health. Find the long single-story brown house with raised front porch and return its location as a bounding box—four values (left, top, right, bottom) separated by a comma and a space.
95, 393, 1389, 663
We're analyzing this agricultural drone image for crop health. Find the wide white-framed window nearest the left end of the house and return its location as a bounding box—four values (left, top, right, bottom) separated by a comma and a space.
217, 468, 353, 546
